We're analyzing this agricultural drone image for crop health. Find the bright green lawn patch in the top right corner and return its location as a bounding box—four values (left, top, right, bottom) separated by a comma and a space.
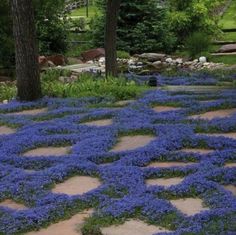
219, 0, 236, 29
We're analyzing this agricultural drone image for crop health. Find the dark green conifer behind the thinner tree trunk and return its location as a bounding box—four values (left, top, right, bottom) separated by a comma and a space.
91, 0, 176, 54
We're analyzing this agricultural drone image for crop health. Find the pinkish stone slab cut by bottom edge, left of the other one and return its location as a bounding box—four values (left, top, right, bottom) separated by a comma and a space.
26, 210, 92, 235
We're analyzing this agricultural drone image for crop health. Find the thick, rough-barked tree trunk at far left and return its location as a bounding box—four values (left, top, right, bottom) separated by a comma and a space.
11, 0, 41, 101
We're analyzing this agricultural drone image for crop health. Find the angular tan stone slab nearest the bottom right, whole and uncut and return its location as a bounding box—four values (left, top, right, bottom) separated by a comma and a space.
170, 198, 209, 216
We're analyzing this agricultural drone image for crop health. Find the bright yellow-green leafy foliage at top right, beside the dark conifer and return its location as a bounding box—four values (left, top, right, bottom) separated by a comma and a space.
169, 0, 224, 43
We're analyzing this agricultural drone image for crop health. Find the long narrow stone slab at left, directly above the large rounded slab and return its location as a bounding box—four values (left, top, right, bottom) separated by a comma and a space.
23, 147, 70, 157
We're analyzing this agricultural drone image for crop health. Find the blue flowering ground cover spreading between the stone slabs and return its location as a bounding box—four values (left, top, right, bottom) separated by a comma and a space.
0, 85, 236, 235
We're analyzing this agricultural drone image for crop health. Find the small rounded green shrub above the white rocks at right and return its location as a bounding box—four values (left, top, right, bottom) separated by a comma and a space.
185, 32, 211, 58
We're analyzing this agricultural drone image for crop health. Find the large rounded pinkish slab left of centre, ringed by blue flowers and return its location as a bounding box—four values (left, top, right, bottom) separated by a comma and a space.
52, 176, 101, 196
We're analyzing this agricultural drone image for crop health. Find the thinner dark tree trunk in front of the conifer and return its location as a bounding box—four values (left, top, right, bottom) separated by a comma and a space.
105, 0, 121, 77
